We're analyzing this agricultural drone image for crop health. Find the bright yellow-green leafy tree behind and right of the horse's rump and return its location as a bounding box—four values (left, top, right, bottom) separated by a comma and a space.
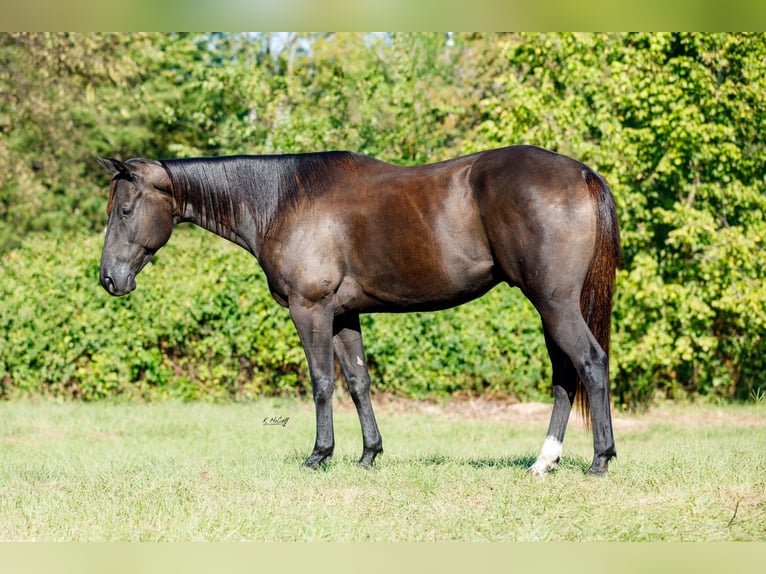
466, 34, 766, 407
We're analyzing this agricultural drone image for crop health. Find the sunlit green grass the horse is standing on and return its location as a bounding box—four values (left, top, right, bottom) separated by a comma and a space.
0, 399, 766, 541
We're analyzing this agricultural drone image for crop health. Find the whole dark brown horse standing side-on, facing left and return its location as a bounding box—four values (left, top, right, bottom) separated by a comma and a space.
99, 146, 620, 475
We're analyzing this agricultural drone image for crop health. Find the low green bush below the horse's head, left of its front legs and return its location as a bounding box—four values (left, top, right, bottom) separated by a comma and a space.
0, 232, 305, 400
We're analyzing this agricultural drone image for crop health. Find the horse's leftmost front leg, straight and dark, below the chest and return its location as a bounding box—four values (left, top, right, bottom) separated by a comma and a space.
289, 300, 335, 468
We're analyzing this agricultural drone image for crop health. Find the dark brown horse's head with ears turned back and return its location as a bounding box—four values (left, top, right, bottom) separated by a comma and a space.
98, 158, 173, 297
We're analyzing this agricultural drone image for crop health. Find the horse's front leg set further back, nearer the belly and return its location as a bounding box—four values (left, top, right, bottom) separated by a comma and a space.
333, 315, 383, 467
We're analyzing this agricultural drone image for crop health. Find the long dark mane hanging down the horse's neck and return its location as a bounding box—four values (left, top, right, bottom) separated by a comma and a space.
161, 152, 355, 236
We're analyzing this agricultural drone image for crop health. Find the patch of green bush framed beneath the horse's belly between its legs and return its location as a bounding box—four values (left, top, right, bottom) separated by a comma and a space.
362, 287, 550, 399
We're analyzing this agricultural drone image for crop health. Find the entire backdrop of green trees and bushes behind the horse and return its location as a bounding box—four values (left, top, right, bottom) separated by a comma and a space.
0, 33, 766, 407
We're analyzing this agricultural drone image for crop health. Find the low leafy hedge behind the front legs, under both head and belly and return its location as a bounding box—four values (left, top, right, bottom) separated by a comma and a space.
0, 229, 549, 400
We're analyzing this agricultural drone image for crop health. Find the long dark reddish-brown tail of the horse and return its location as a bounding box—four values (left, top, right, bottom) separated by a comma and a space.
577, 170, 620, 428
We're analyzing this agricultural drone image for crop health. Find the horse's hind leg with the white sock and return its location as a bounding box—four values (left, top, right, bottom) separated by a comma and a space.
529, 329, 577, 476
